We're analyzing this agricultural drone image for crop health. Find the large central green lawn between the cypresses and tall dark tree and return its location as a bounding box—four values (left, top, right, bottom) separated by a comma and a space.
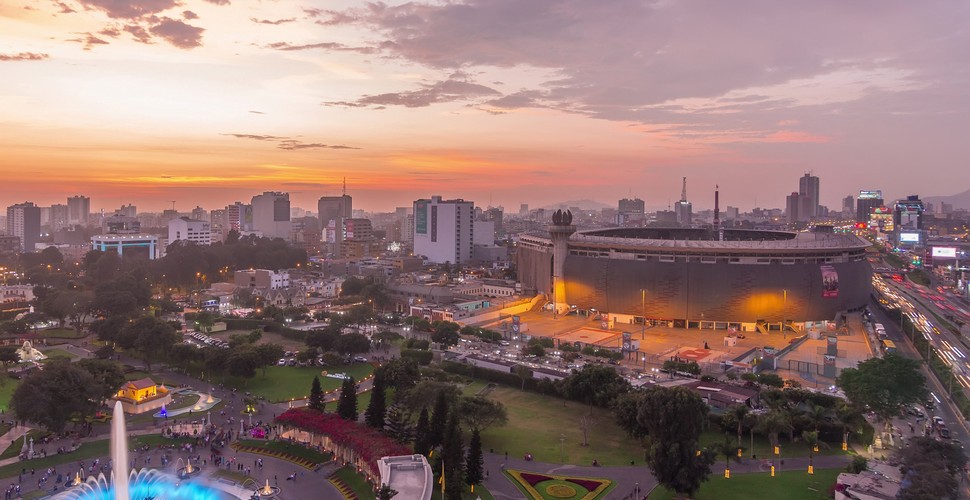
482, 386, 644, 465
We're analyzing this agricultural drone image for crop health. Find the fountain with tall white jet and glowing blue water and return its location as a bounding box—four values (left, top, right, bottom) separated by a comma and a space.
53, 402, 236, 500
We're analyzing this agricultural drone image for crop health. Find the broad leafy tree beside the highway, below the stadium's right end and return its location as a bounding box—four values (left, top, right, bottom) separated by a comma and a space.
836, 353, 927, 432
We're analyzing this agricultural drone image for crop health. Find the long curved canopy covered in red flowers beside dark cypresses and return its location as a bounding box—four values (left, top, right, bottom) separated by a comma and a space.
276, 408, 412, 469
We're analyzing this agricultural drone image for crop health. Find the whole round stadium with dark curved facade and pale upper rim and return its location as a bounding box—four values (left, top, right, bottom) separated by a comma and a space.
517, 228, 872, 327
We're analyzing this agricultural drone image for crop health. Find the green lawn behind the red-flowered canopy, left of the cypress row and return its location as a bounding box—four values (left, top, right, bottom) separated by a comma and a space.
226, 363, 374, 402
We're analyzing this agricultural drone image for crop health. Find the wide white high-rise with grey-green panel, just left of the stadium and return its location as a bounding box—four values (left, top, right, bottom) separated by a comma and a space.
414, 196, 475, 264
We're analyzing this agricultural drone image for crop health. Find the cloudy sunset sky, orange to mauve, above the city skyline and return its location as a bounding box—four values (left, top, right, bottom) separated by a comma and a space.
0, 0, 970, 211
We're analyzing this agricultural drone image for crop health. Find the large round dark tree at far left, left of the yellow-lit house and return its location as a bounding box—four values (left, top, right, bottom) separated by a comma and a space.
10, 359, 98, 432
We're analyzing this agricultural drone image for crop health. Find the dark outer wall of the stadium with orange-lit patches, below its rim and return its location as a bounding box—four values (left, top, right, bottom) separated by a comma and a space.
518, 231, 871, 322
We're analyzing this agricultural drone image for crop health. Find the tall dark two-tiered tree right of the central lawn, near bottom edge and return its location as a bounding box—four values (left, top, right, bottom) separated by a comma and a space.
638, 387, 714, 496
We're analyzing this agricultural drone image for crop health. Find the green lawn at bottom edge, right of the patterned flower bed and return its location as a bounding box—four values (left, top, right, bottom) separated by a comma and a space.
649, 469, 843, 500
